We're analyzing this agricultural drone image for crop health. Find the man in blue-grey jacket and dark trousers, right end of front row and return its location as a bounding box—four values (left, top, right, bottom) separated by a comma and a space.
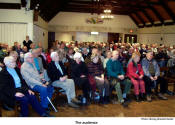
141, 51, 168, 102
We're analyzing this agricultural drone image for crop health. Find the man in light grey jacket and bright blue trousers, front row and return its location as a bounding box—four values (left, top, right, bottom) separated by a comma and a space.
21, 52, 53, 110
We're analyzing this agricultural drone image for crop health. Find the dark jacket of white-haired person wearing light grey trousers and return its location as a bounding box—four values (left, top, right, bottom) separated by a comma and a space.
47, 61, 67, 82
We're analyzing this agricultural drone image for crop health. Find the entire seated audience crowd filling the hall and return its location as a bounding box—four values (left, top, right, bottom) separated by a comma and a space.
0, 37, 175, 117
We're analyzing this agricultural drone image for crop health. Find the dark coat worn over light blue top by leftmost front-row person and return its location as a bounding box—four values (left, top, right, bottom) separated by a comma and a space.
0, 67, 29, 107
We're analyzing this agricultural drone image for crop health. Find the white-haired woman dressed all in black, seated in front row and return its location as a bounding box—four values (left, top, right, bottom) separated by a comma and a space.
71, 52, 90, 104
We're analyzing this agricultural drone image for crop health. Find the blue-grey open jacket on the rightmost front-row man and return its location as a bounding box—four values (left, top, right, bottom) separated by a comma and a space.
141, 58, 160, 77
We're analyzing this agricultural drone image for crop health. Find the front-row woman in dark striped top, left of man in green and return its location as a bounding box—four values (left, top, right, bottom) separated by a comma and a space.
88, 55, 109, 104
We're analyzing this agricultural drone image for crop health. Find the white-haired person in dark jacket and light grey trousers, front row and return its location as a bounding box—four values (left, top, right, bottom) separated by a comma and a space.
47, 52, 80, 108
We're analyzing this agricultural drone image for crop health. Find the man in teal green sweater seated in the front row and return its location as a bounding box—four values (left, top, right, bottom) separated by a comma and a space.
106, 50, 131, 107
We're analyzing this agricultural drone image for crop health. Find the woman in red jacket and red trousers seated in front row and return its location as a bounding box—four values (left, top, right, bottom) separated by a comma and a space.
126, 52, 145, 102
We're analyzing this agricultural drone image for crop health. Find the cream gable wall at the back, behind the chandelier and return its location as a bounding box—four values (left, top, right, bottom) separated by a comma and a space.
49, 12, 137, 33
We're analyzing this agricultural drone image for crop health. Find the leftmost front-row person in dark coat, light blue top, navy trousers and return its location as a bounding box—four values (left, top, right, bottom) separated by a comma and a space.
0, 56, 48, 117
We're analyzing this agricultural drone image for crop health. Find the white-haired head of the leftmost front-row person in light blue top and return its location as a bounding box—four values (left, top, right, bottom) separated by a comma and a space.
4, 56, 16, 68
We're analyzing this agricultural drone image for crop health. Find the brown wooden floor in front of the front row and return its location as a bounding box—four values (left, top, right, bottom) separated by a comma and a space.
2, 86, 175, 117
